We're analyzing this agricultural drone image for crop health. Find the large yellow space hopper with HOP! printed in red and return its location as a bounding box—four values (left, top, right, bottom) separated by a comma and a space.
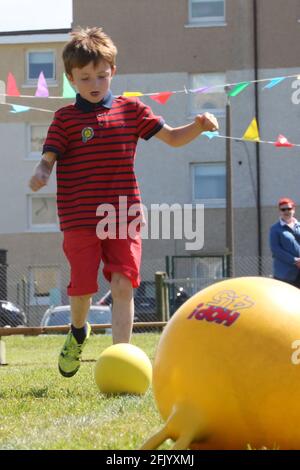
142, 277, 300, 450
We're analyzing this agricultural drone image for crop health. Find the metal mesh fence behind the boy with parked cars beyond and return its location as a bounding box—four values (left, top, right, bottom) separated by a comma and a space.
0, 256, 272, 327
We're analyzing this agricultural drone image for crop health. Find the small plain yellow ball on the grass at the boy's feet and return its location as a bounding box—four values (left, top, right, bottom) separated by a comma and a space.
94, 343, 152, 395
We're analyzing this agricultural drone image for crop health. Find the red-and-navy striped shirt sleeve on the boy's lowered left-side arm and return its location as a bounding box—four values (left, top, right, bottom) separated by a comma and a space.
43, 111, 68, 157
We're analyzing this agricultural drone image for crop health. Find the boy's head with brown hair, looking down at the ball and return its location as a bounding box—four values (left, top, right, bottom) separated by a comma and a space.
63, 28, 117, 103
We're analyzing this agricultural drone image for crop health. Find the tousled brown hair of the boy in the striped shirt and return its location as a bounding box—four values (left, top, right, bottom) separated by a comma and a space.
62, 27, 117, 75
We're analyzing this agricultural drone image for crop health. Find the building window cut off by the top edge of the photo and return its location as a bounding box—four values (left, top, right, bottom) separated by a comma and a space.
189, 0, 225, 25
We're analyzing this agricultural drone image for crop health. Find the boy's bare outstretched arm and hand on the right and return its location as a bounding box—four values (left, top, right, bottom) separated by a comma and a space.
155, 113, 219, 147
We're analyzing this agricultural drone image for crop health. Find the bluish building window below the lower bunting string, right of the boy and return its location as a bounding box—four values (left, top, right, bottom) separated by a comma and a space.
191, 162, 226, 207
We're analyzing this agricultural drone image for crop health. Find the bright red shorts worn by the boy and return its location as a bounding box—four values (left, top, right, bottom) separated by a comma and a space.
63, 228, 142, 296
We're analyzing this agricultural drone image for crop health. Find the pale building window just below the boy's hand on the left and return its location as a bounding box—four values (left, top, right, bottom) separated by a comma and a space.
28, 194, 58, 231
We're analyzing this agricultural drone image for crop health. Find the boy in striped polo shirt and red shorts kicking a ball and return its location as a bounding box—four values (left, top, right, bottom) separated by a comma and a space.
29, 28, 218, 377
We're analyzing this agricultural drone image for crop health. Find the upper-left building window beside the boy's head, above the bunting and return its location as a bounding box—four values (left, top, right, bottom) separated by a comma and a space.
27, 51, 56, 83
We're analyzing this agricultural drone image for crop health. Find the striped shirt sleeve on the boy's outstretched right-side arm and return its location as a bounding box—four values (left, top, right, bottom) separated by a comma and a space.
136, 99, 165, 140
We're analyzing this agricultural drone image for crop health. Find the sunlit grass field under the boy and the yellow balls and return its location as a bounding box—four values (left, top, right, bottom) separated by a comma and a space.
0, 333, 168, 450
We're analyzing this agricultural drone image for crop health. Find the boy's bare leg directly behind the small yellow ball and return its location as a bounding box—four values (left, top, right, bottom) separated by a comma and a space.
111, 273, 134, 344
